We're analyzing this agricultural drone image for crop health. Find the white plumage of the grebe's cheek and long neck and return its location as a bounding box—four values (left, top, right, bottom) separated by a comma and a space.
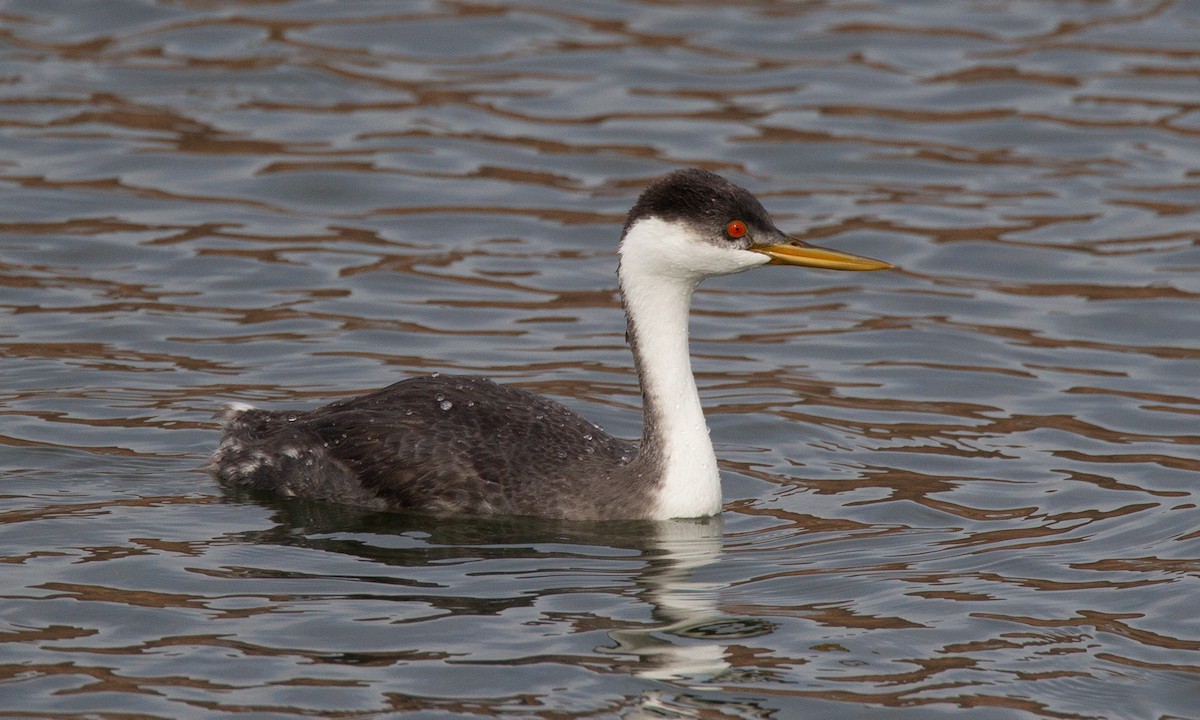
620, 218, 769, 520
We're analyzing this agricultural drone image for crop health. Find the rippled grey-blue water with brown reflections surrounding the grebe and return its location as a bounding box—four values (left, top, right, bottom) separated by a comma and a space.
0, 0, 1200, 719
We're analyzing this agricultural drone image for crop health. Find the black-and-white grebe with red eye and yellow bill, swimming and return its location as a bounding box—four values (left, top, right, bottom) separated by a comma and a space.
211, 169, 892, 520
